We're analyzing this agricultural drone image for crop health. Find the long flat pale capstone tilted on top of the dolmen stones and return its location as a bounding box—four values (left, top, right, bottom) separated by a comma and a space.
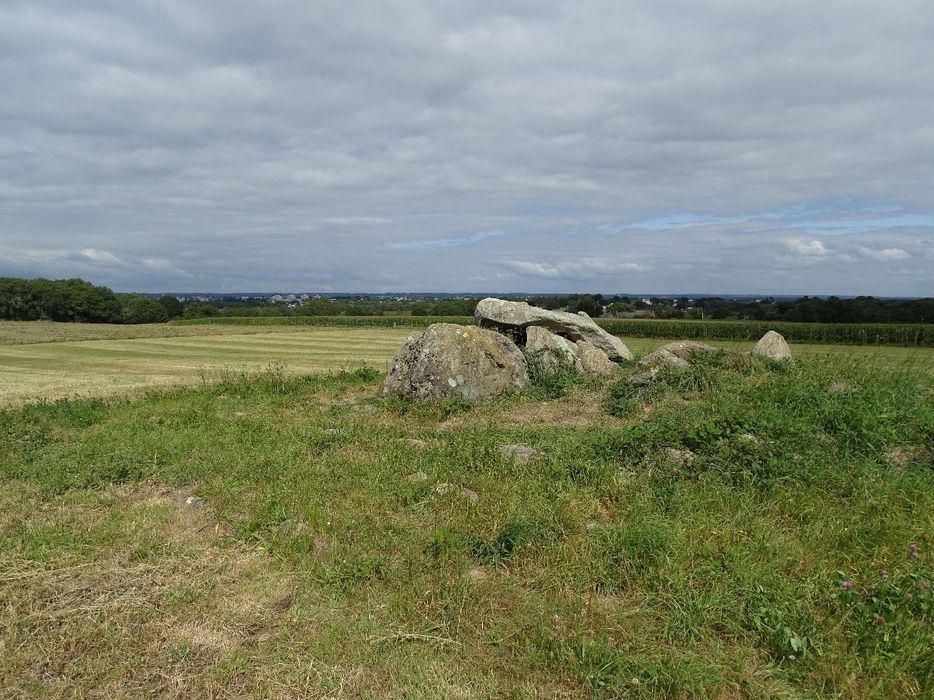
474, 297, 632, 362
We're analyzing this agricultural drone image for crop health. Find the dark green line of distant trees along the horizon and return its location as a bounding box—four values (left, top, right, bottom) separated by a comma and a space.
0, 277, 934, 323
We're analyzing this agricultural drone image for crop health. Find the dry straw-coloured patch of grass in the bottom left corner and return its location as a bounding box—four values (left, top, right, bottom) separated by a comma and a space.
0, 485, 310, 698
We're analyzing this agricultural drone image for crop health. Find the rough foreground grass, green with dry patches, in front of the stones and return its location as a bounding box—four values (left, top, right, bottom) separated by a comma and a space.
0, 355, 934, 698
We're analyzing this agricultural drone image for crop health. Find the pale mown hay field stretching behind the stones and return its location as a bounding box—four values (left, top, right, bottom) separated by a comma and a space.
0, 322, 934, 405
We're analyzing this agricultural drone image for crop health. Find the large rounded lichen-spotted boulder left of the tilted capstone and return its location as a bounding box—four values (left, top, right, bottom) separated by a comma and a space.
383, 323, 529, 400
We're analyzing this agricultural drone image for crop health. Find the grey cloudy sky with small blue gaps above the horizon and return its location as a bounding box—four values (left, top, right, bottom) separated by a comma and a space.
0, 0, 934, 296
